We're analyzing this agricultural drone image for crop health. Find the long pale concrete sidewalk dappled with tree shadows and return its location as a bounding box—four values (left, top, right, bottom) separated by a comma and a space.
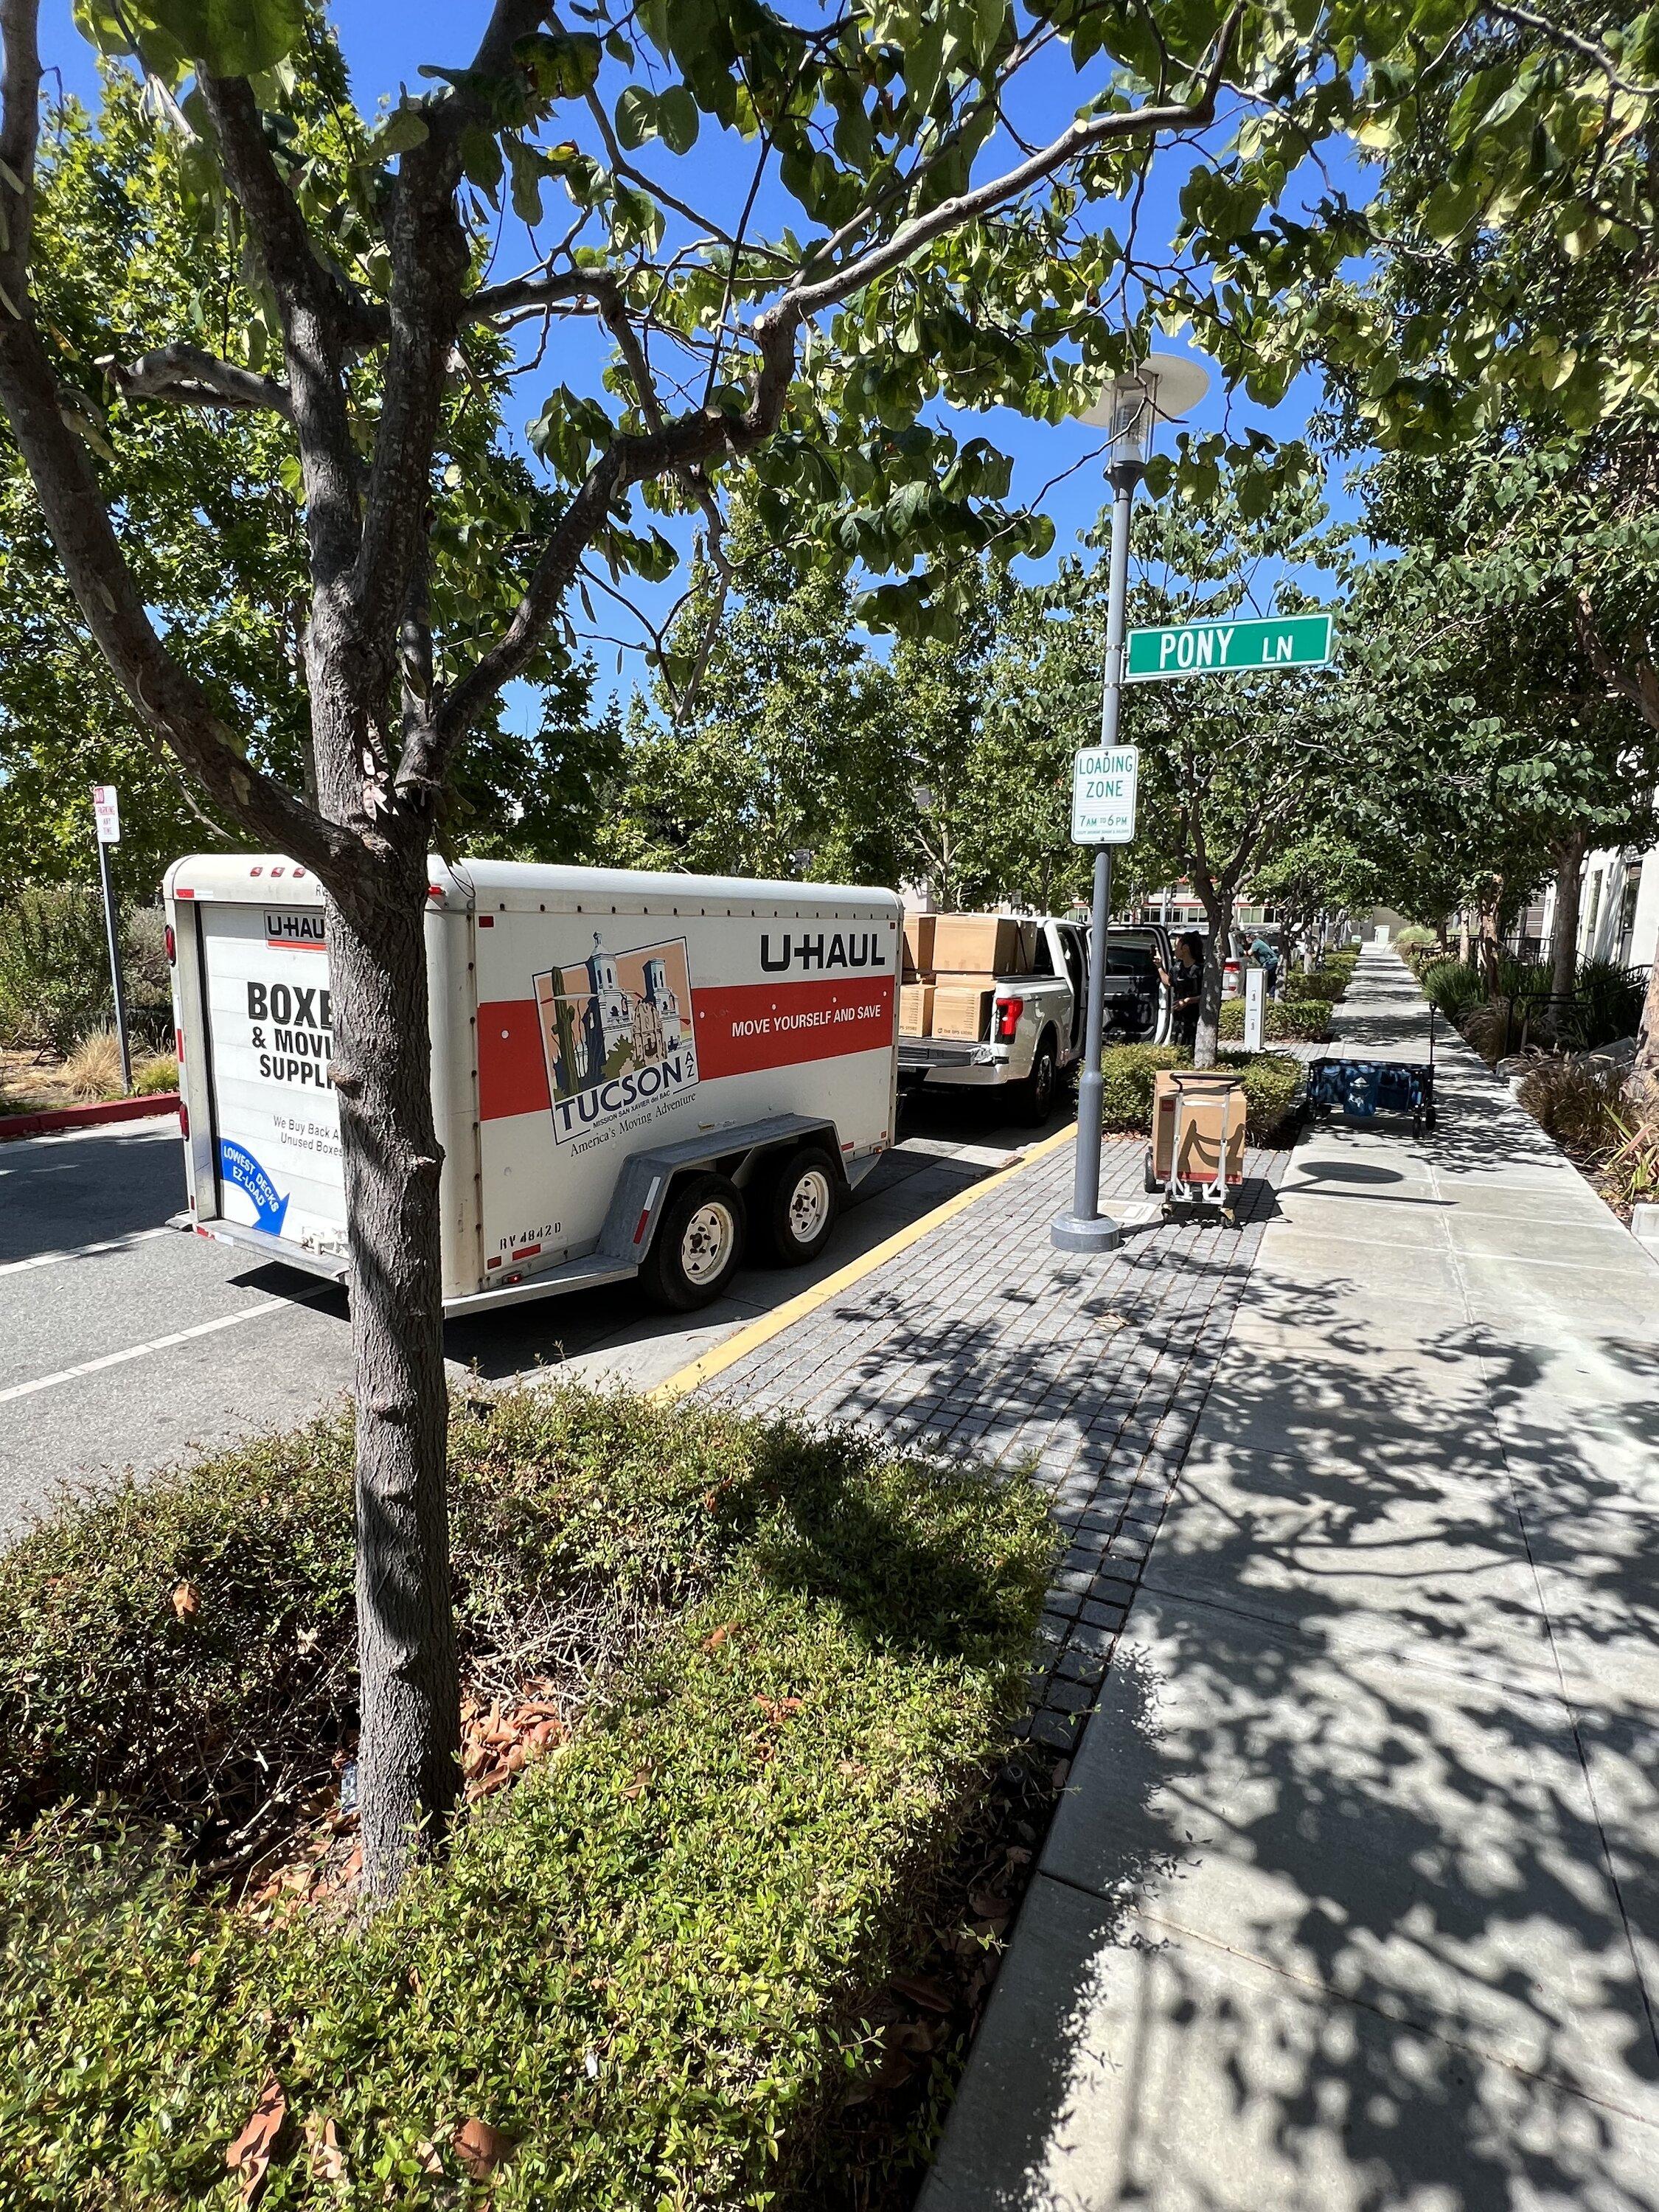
922, 951, 1659, 2212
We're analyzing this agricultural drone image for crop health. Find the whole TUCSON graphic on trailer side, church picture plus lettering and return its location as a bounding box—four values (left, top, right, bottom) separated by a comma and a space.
535, 933, 697, 1144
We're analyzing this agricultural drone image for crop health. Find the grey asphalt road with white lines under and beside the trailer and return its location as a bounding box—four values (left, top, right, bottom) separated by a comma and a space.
0, 1097, 1060, 1540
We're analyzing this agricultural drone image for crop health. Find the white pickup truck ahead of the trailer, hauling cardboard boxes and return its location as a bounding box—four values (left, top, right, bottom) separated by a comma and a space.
898, 914, 1175, 1126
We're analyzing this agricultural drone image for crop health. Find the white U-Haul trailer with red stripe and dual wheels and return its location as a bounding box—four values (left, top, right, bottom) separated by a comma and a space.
166, 854, 900, 1312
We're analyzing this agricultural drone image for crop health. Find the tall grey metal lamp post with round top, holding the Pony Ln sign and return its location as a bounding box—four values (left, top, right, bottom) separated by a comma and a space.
1048, 354, 1210, 1252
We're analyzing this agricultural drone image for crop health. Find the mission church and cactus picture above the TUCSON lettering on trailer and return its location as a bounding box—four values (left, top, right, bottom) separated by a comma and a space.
535, 929, 692, 1099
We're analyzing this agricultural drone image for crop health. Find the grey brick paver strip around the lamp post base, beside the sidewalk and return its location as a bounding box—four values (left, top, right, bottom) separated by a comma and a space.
697, 1141, 1287, 1752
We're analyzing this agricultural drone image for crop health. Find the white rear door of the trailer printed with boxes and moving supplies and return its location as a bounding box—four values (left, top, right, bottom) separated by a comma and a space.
197, 900, 345, 1254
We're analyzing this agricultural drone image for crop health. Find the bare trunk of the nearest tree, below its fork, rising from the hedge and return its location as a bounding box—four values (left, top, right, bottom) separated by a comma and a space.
327, 872, 460, 1893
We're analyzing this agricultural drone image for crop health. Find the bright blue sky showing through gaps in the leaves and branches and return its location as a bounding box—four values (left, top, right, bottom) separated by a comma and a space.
42, 0, 1371, 721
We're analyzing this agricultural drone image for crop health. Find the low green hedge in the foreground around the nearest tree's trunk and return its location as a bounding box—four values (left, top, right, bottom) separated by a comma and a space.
0, 1389, 1053, 2212
